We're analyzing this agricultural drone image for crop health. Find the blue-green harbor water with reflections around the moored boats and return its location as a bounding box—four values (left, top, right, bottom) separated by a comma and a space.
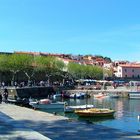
42, 97, 140, 132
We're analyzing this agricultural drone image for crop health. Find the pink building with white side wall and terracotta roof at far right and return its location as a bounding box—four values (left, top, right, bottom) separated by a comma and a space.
115, 63, 140, 78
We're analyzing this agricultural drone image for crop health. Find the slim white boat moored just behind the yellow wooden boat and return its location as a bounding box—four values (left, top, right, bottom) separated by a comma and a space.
64, 104, 94, 113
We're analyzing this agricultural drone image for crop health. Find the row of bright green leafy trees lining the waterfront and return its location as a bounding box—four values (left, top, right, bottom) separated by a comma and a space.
0, 54, 112, 80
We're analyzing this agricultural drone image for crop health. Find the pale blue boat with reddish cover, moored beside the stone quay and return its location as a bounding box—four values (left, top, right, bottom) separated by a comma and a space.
29, 99, 66, 109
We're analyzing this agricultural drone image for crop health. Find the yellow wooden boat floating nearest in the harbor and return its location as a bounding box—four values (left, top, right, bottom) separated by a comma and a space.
75, 108, 115, 117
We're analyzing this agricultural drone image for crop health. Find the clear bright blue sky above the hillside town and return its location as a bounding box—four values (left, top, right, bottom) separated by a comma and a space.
0, 0, 140, 61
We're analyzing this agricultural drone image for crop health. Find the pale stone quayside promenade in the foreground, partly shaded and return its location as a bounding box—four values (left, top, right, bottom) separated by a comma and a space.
0, 103, 140, 140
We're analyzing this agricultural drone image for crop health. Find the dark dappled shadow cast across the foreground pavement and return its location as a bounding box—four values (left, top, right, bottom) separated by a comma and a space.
0, 112, 136, 140
